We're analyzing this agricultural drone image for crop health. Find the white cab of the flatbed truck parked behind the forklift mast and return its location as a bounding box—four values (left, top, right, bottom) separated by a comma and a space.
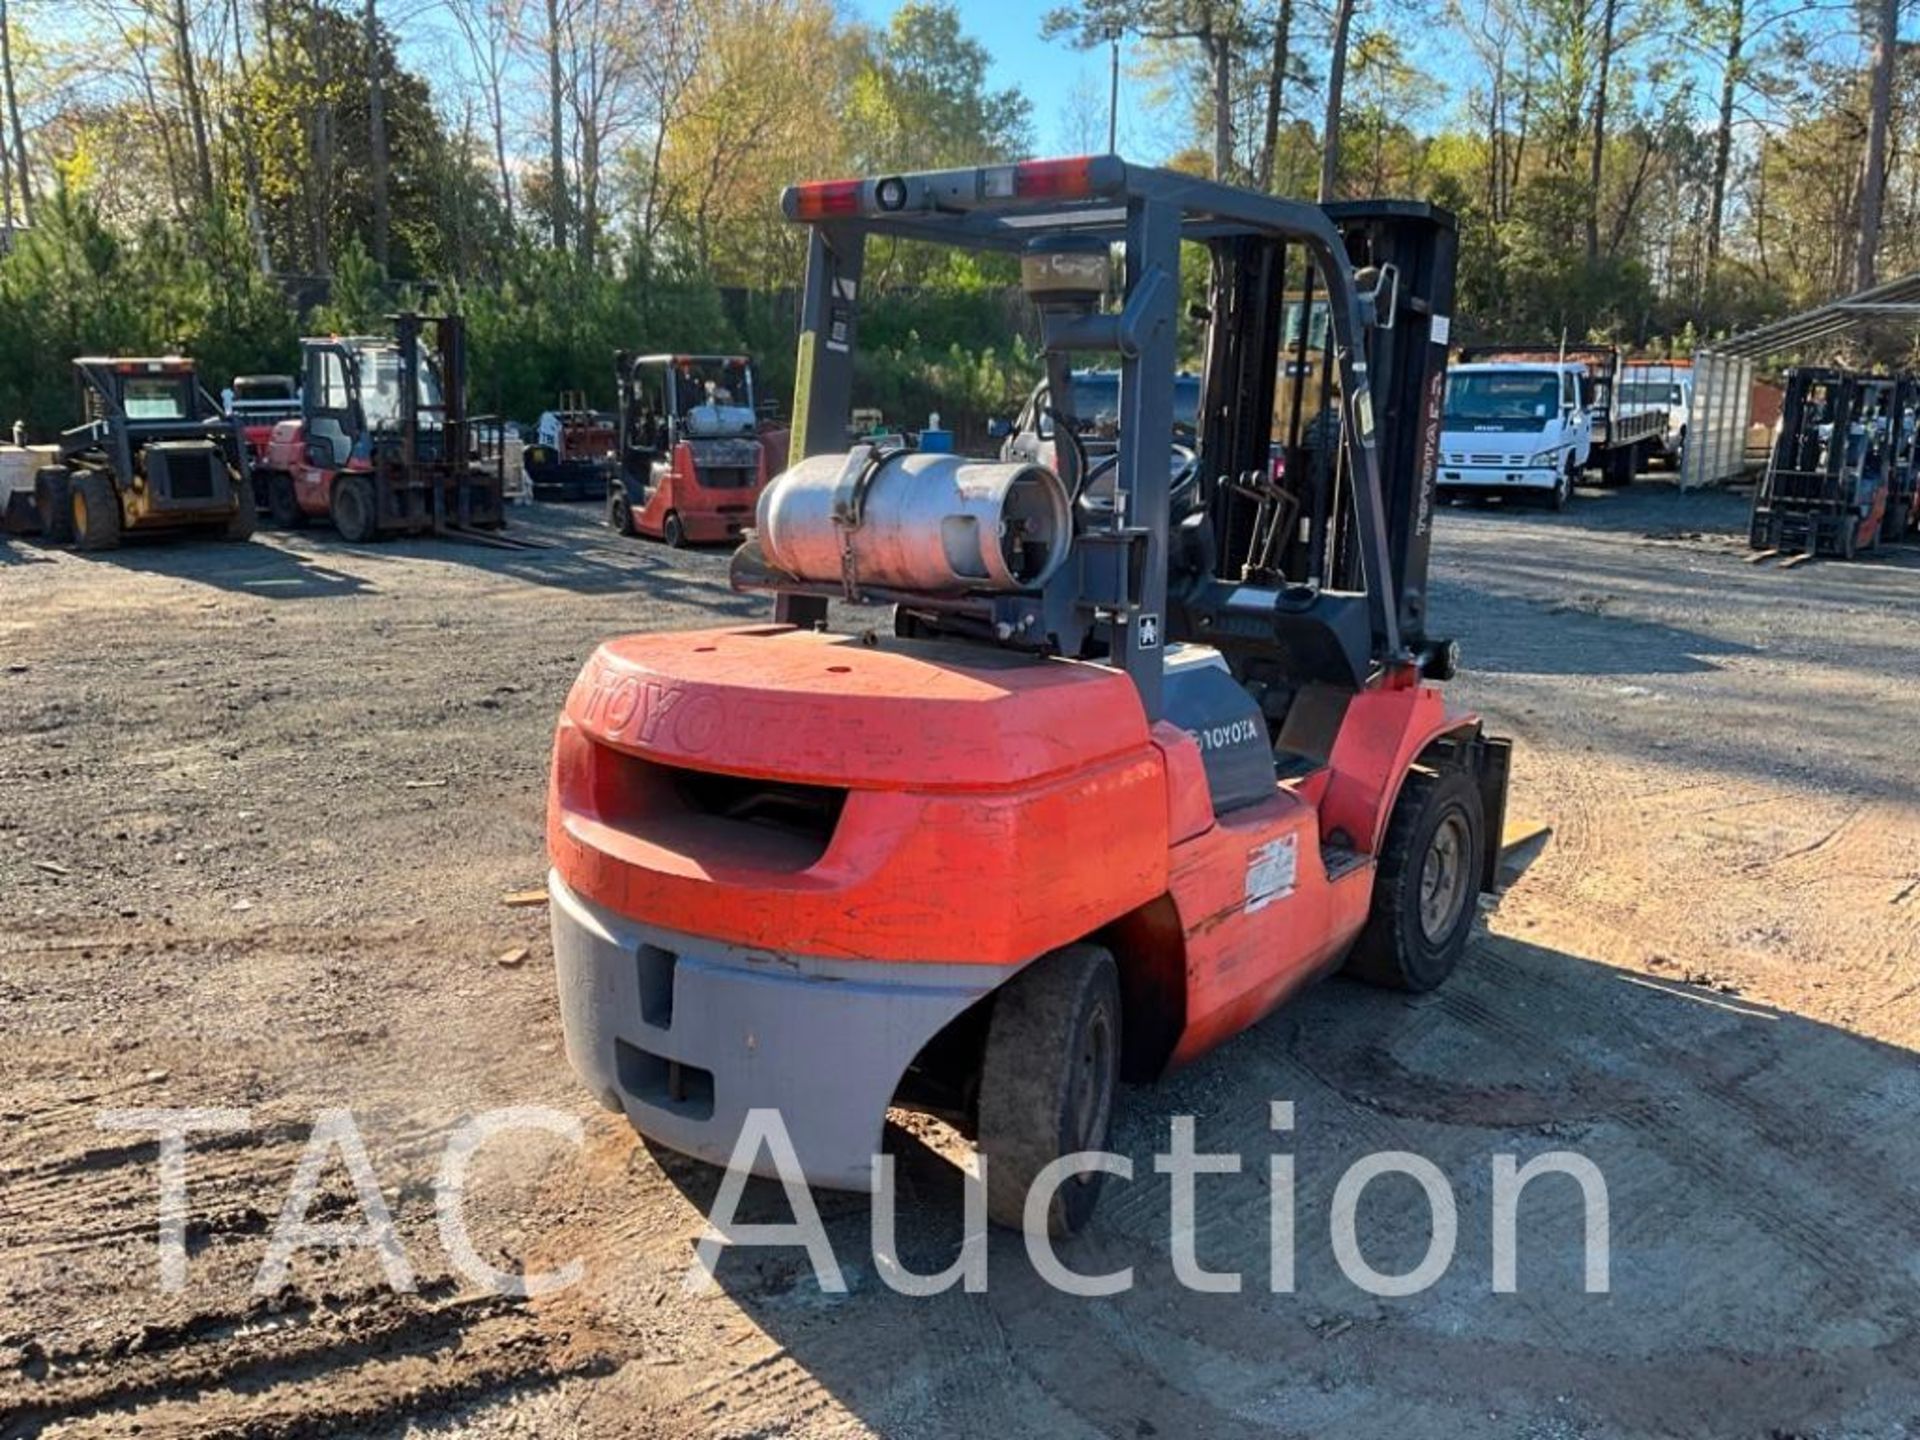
1438, 363, 1603, 511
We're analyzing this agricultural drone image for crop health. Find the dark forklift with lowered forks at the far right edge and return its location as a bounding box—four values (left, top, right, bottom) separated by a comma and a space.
1747, 367, 1920, 561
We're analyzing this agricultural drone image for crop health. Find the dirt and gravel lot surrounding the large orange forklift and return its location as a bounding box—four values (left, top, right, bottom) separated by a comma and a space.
0, 484, 1920, 1440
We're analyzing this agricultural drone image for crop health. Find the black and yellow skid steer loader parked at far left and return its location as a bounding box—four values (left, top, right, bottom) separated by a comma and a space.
35, 355, 253, 549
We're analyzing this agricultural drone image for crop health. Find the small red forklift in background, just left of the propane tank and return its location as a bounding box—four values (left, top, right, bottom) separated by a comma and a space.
607, 349, 787, 549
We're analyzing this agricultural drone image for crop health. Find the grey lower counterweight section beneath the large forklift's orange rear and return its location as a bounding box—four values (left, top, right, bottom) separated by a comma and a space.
547, 874, 1018, 1190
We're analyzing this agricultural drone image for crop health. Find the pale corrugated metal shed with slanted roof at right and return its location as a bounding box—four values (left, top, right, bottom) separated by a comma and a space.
1680, 271, 1920, 488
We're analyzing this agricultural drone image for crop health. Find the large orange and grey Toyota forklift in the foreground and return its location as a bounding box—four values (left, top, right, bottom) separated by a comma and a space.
547, 156, 1509, 1235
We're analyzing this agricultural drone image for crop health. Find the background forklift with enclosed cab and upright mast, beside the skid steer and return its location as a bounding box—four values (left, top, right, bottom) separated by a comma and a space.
255, 313, 528, 549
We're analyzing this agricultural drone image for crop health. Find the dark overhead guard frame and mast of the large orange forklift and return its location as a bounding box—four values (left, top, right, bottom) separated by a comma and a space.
748, 156, 1455, 718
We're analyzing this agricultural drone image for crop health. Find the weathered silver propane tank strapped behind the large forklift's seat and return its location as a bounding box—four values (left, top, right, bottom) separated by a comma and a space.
755, 449, 1073, 593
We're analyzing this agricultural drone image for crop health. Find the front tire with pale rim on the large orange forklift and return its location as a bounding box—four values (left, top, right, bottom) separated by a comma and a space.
1346, 766, 1486, 991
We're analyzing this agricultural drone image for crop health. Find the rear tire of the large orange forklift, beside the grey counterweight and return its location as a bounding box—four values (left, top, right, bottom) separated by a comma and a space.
979, 945, 1119, 1238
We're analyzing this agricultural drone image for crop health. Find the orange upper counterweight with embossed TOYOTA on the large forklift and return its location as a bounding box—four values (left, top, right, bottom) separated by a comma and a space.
549, 626, 1167, 964
